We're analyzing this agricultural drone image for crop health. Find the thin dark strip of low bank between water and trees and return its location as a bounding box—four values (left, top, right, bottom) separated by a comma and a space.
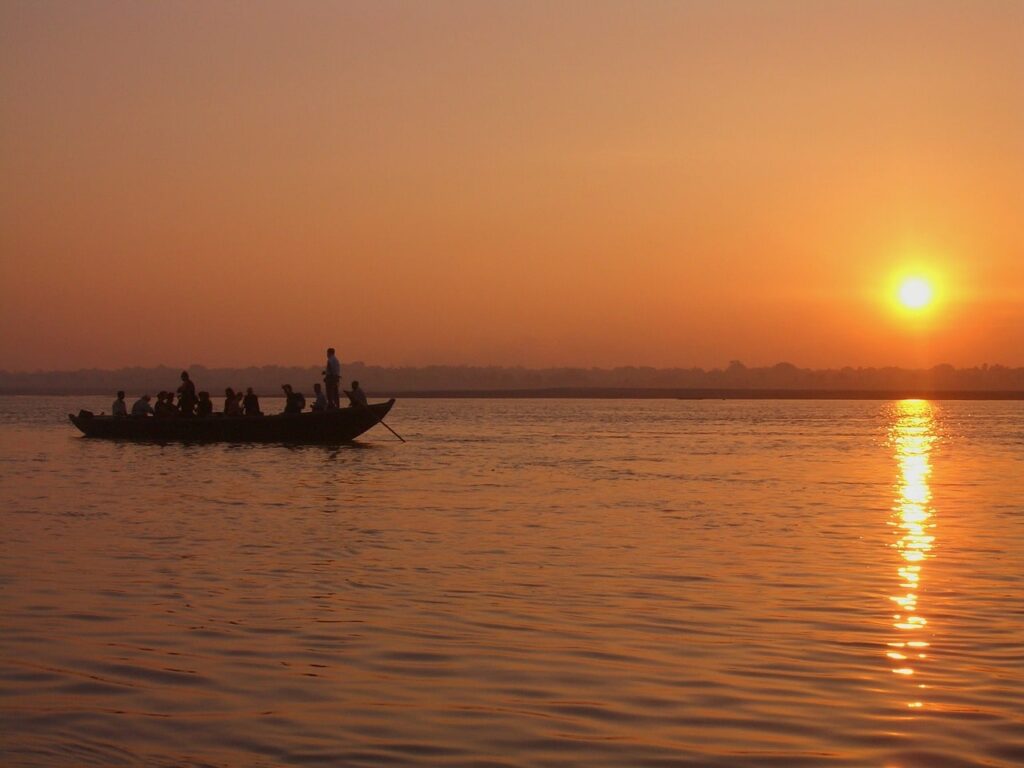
0, 387, 1024, 400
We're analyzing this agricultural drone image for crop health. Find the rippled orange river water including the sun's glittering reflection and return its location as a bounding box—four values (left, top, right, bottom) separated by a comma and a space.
0, 397, 1024, 768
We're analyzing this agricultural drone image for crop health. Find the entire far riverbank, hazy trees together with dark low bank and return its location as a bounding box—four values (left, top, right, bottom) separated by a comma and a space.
6, 360, 1024, 399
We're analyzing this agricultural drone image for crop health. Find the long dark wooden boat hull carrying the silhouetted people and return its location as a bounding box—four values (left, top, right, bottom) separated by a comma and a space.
68, 398, 394, 443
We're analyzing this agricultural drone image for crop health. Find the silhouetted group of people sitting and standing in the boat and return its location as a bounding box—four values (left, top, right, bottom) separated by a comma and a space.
104, 347, 367, 418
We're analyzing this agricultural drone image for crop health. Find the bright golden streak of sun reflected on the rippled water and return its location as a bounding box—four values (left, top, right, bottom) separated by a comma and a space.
886, 400, 935, 709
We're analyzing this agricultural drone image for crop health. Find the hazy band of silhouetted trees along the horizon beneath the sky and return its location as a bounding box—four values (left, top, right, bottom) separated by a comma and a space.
0, 360, 1024, 396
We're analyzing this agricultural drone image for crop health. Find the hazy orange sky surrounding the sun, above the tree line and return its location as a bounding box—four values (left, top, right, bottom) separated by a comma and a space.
0, 0, 1024, 371
